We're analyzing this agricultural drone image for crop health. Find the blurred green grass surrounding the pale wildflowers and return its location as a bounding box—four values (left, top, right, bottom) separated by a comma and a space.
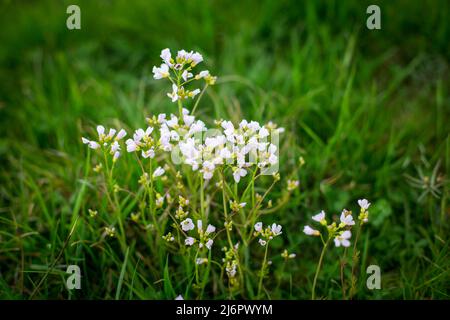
0, 0, 450, 299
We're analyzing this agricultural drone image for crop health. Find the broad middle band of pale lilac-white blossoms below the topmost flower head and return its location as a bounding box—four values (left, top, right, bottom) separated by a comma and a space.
82, 108, 284, 185
